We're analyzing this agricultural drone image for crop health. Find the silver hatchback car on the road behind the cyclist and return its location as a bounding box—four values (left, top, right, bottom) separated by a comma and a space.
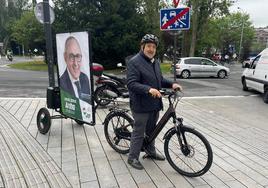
171, 57, 230, 78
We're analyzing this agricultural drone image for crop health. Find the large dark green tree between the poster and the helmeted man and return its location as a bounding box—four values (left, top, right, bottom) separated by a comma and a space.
53, 0, 146, 68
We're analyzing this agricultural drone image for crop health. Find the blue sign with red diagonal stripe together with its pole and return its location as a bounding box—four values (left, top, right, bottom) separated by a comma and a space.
160, 3, 190, 81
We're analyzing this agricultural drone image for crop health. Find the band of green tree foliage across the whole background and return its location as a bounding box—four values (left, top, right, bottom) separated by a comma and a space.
0, 0, 260, 64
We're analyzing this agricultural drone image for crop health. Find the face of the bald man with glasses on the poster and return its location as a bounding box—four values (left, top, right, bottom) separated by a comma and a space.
64, 40, 82, 80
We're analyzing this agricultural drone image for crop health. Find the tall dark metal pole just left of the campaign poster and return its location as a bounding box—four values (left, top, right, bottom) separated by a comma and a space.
43, 0, 55, 87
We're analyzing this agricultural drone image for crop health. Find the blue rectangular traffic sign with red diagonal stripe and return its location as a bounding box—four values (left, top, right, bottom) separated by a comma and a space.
160, 7, 190, 31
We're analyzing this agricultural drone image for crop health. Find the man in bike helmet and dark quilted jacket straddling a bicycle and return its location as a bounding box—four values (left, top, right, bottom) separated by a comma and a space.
127, 34, 181, 170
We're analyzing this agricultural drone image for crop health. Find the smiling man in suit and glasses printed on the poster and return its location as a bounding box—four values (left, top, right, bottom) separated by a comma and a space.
60, 36, 90, 101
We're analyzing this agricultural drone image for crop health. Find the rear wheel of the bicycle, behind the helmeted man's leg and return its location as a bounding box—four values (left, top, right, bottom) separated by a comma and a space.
104, 111, 133, 154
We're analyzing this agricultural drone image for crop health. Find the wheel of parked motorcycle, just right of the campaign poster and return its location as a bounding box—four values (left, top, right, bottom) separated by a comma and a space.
94, 85, 113, 106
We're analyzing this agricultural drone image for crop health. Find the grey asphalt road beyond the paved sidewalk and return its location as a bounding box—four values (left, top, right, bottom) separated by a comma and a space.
0, 57, 257, 97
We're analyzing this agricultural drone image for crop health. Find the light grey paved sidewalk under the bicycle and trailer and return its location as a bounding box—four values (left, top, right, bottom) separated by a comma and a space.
0, 97, 268, 188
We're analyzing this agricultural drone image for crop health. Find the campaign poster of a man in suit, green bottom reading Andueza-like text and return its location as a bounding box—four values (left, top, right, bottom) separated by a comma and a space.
56, 32, 94, 124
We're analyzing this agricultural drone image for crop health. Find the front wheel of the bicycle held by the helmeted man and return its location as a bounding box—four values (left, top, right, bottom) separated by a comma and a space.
164, 127, 213, 177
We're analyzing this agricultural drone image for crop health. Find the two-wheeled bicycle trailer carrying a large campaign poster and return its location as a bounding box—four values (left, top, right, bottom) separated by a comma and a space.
37, 32, 95, 134
